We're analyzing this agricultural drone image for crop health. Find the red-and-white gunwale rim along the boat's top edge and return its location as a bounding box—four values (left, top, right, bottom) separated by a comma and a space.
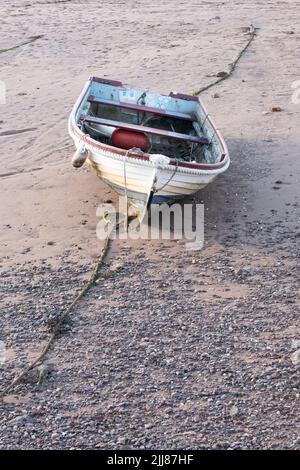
69, 77, 230, 174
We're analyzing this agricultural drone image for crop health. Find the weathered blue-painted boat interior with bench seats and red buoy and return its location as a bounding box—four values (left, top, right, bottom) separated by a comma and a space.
77, 79, 214, 163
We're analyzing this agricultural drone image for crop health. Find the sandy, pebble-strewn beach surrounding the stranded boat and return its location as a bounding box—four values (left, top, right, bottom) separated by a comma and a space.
0, 0, 300, 449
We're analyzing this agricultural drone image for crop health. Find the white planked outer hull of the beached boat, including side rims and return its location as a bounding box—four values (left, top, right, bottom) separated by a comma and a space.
69, 76, 230, 211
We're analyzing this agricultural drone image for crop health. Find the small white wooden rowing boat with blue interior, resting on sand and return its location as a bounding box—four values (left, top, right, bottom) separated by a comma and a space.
69, 77, 230, 217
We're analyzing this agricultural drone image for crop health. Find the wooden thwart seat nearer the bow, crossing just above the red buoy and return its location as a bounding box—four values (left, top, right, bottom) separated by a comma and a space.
80, 114, 209, 144
